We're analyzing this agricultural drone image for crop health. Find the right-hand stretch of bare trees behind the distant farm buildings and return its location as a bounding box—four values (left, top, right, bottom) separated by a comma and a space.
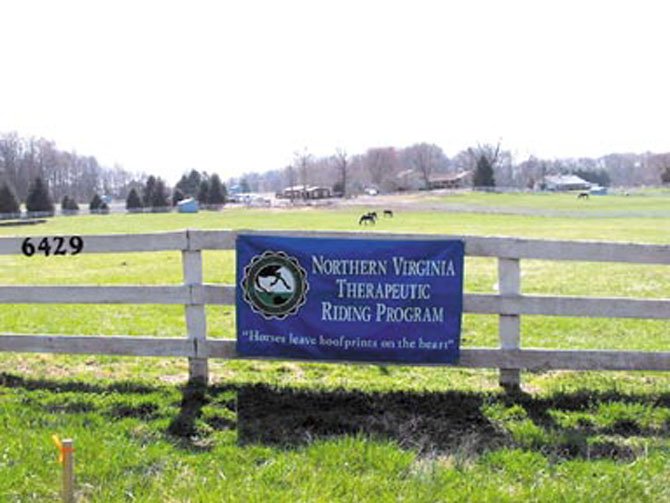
230, 143, 670, 195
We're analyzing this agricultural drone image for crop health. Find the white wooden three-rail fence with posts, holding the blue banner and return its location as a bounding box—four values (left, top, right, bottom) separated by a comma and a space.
0, 230, 670, 387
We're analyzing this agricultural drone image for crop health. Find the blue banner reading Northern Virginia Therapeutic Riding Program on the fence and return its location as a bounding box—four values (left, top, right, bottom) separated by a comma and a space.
236, 235, 464, 363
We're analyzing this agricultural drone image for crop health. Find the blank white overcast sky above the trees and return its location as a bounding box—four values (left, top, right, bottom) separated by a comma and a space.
0, 0, 670, 182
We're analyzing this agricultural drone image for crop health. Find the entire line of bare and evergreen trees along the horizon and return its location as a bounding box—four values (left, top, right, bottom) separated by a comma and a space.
0, 128, 670, 214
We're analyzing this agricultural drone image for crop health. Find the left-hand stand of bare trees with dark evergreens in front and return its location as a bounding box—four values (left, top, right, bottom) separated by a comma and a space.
0, 133, 227, 215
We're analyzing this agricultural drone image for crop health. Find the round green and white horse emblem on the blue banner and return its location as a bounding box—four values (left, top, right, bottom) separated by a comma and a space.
241, 251, 309, 320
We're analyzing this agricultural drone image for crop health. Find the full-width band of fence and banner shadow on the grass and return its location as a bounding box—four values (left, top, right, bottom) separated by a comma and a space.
0, 373, 670, 461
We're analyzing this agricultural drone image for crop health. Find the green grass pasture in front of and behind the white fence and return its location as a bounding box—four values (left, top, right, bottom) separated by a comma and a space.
0, 194, 670, 501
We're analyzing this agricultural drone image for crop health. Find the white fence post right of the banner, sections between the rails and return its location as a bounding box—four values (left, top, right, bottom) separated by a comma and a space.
498, 257, 521, 391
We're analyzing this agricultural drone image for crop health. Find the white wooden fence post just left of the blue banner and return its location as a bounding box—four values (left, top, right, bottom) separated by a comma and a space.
182, 231, 209, 384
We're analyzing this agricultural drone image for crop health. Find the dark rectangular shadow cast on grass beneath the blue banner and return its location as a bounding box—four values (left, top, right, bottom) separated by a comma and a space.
237, 386, 505, 453
